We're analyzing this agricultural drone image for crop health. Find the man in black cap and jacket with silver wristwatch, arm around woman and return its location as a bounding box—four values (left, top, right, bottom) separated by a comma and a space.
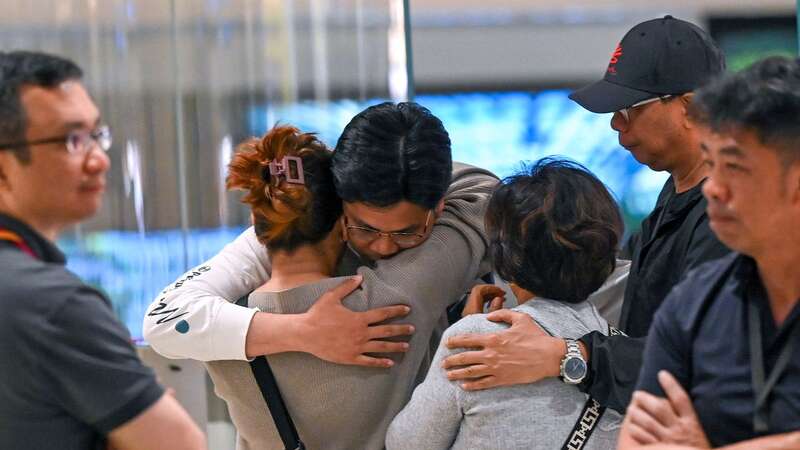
445, 16, 729, 411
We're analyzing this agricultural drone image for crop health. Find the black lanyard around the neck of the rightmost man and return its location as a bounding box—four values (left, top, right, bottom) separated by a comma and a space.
747, 299, 800, 433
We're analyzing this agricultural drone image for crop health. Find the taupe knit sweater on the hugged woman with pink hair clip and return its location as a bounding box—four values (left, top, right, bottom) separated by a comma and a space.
203, 165, 497, 450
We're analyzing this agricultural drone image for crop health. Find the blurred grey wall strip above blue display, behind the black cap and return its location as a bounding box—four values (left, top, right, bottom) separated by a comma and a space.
411, 0, 796, 92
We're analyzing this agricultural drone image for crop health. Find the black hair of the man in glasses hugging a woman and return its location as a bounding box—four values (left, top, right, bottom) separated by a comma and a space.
333, 102, 453, 209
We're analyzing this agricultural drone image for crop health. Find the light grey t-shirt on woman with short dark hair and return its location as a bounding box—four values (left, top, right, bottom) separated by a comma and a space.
386, 298, 622, 450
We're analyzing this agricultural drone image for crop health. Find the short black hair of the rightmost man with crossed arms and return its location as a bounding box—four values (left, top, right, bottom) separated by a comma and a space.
692, 56, 800, 163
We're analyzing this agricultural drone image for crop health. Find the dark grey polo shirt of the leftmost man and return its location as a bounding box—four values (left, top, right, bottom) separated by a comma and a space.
0, 214, 163, 450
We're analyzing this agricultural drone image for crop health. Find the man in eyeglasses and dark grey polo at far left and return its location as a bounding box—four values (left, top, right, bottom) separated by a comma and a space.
0, 52, 205, 450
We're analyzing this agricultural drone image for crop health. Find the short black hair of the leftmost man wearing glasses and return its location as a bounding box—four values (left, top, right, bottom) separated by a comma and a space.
0, 51, 83, 162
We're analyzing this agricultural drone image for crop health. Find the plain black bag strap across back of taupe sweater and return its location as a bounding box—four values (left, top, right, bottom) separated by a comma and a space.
236, 294, 306, 450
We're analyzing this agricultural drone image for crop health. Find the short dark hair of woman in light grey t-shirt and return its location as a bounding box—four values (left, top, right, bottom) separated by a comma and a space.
486, 158, 623, 303
